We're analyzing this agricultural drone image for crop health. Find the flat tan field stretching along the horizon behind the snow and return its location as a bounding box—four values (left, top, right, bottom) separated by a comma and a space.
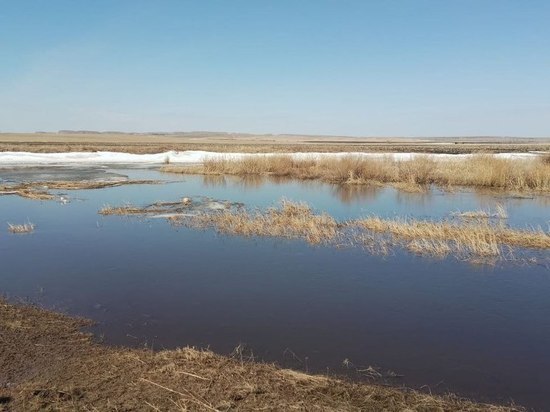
0, 132, 550, 153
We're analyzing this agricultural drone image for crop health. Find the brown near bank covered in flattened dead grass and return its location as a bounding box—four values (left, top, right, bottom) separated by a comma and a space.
0, 300, 522, 411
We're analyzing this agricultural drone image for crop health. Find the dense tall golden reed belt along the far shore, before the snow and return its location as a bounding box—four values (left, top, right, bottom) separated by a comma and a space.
161, 155, 550, 193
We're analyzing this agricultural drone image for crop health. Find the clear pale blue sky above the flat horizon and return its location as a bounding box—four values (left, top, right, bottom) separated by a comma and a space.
0, 0, 550, 137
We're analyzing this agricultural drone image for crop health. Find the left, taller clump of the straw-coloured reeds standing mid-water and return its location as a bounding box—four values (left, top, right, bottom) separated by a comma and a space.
188, 200, 338, 244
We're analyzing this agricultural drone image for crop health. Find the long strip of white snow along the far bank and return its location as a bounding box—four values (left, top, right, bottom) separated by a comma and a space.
0, 150, 540, 166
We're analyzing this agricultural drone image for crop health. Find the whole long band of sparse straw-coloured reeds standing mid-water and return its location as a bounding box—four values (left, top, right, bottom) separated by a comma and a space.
171, 201, 550, 260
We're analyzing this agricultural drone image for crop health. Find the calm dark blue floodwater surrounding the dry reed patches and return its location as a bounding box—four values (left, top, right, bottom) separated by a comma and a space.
0, 167, 550, 410
